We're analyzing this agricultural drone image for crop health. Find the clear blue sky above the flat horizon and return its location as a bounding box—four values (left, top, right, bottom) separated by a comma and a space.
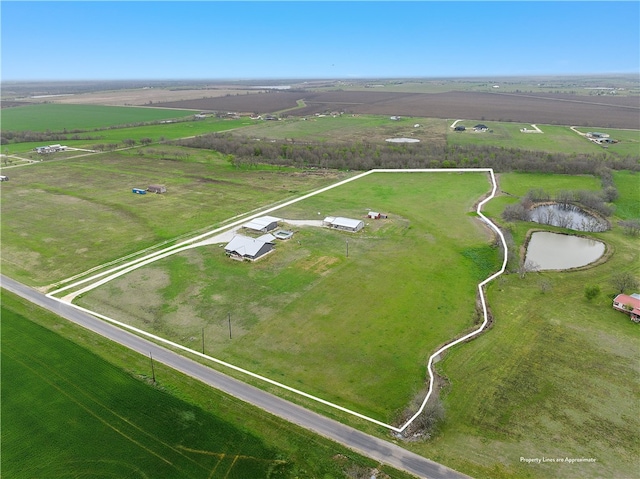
0, 0, 640, 80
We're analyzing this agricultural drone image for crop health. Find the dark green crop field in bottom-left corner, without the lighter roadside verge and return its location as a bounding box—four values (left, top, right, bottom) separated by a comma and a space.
2, 300, 288, 478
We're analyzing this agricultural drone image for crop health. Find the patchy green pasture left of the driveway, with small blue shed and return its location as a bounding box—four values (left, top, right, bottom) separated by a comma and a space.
1, 147, 348, 286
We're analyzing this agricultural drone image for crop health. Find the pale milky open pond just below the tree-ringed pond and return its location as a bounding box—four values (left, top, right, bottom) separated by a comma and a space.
525, 231, 605, 270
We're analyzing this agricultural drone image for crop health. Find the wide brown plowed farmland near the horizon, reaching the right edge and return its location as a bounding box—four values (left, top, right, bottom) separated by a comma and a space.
156, 91, 640, 129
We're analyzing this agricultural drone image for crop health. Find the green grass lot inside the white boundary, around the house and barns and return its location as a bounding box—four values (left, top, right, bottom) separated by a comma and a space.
79, 173, 500, 421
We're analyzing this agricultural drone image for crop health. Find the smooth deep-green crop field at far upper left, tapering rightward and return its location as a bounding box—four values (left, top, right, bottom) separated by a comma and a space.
0, 103, 198, 132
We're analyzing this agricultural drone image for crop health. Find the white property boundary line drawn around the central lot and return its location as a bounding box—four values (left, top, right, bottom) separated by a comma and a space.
47, 168, 508, 433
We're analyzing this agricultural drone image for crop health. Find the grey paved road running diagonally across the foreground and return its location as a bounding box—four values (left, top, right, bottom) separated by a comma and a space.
0, 275, 468, 479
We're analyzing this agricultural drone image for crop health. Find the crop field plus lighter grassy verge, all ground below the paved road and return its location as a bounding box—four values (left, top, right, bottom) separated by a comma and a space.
2, 291, 407, 479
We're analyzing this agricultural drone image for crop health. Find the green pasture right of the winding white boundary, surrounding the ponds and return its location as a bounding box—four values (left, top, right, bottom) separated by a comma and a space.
396, 172, 640, 479
